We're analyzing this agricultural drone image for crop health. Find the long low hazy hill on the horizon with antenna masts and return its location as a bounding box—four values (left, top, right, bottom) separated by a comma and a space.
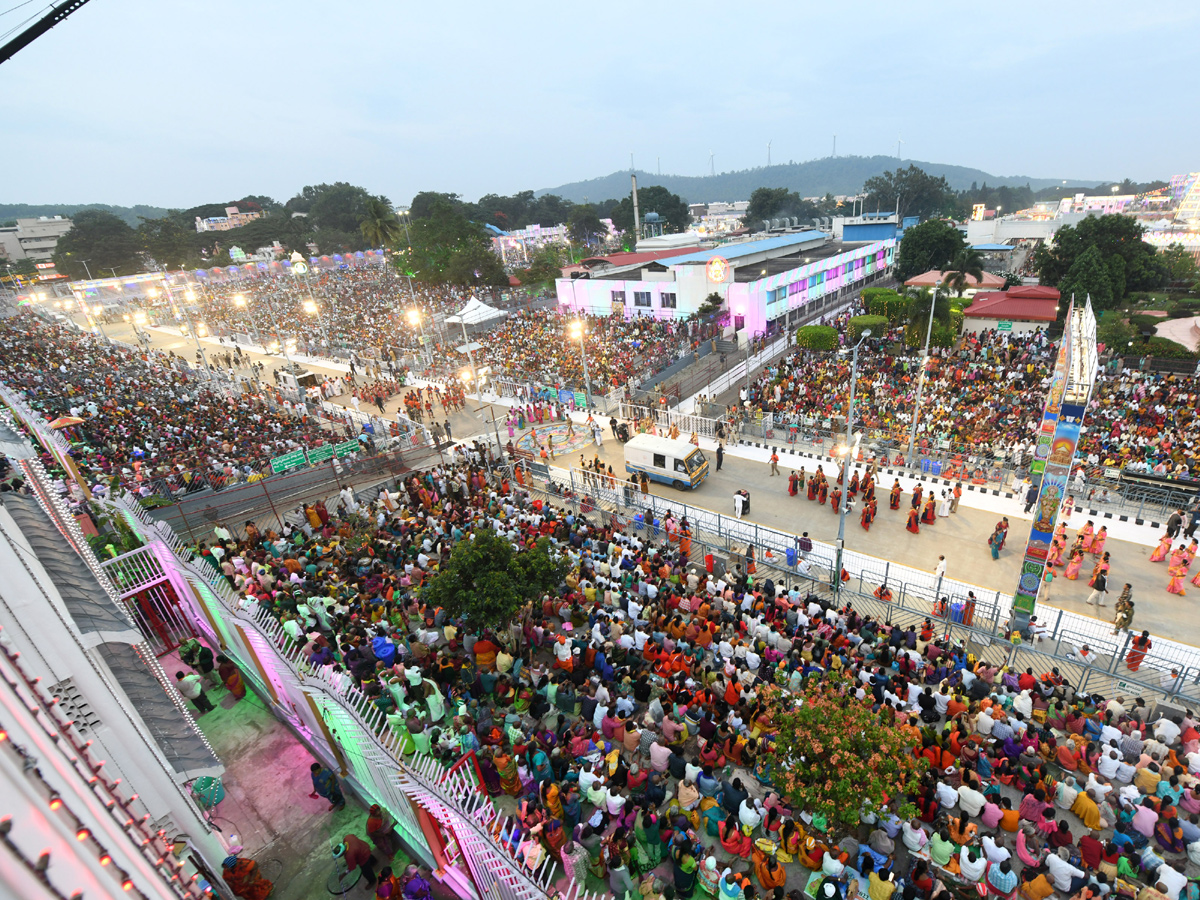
540, 156, 1102, 209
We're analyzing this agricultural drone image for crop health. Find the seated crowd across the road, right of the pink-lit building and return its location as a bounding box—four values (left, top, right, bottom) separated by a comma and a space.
731, 329, 1200, 480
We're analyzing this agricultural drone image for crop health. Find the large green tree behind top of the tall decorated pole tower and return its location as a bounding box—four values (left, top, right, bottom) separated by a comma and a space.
1034, 214, 1168, 310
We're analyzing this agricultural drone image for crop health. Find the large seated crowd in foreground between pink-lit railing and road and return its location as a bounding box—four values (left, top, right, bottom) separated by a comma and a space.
162, 463, 1200, 900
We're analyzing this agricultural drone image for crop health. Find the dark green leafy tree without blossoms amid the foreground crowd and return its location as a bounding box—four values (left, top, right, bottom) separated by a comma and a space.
421, 528, 568, 634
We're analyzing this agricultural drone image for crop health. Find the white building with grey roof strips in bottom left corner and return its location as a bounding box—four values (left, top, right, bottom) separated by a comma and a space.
0, 461, 226, 898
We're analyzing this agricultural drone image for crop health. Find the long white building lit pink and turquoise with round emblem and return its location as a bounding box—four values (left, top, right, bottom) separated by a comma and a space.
556, 230, 896, 335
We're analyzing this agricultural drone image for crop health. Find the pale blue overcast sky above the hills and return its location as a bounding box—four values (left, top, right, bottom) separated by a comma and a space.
0, 0, 1200, 208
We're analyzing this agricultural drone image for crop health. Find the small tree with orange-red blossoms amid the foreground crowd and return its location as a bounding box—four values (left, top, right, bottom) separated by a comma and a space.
760, 676, 929, 834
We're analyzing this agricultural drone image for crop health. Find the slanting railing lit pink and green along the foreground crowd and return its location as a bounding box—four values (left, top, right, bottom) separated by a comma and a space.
99, 494, 596, 900
